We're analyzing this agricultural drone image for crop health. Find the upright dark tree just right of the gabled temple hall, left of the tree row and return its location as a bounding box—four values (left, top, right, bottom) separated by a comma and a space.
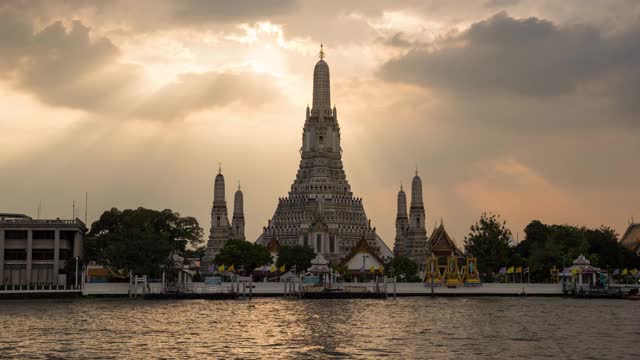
464, 213, 513, 278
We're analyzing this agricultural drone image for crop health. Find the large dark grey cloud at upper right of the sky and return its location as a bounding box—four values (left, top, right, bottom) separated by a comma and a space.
381, 13, 640, 105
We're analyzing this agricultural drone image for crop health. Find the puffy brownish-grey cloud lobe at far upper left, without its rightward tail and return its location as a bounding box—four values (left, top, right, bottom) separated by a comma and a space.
0, 13, 139, 111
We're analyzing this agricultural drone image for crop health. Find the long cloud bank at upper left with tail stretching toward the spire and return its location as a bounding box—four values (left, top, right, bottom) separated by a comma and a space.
0, 8, 273, 120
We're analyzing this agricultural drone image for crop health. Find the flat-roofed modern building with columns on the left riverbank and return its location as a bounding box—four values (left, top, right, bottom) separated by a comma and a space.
0, 213, 87, 285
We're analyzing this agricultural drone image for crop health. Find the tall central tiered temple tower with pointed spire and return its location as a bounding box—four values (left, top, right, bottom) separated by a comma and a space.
258, 47, 393, 263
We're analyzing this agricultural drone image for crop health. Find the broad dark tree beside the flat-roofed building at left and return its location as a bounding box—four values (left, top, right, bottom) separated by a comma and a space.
85, 207, 203, 275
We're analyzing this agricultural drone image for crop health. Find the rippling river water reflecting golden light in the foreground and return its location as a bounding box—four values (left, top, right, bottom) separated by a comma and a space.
0, 298, 640, 359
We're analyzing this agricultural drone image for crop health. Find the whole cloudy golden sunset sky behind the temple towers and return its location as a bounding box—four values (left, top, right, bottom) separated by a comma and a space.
0, 0, 640, 246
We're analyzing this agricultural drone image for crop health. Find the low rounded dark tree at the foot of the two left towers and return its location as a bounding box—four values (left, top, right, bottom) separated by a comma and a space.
214, 240, 271, 272
